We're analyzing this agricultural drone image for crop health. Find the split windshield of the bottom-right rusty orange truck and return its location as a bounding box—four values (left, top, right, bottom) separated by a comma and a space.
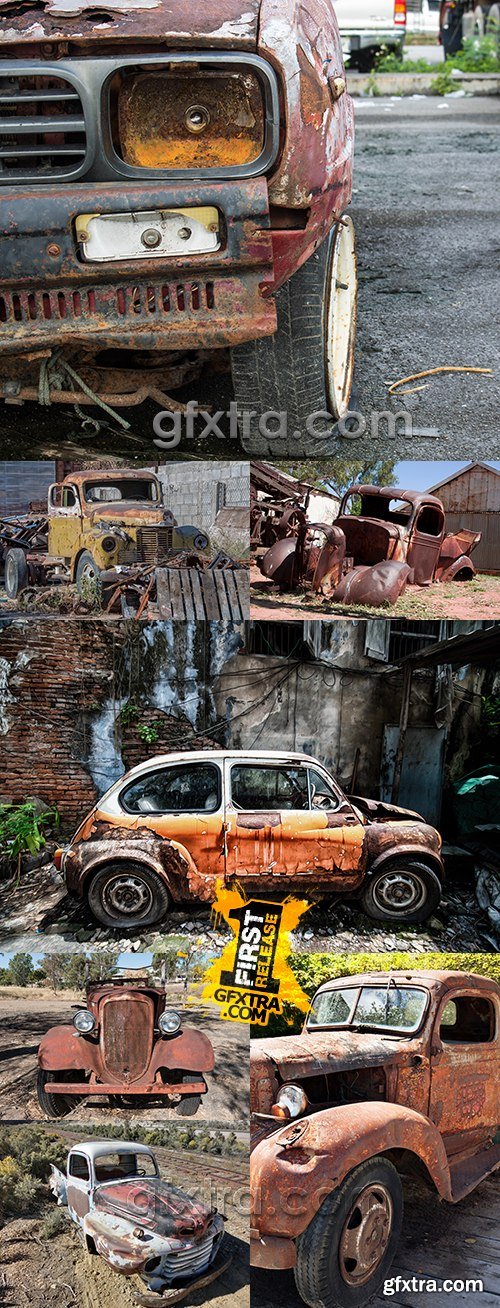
308, 978, 427, 1032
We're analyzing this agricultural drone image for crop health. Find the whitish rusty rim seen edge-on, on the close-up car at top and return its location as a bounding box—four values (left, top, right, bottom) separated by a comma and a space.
325, 217, 356, 420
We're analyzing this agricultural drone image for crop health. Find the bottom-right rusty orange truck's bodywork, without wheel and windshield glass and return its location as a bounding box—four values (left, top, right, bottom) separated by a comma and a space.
250, 969, 500, 1271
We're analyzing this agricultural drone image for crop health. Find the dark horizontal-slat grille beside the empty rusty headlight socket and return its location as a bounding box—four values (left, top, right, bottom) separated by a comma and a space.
0, 73, 86, 182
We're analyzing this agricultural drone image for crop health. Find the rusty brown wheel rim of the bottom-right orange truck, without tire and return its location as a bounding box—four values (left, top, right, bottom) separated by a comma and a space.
339, 1182, 394, 1287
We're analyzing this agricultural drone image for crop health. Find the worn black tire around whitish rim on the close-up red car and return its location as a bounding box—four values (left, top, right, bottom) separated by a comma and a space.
230, 220, 356, 458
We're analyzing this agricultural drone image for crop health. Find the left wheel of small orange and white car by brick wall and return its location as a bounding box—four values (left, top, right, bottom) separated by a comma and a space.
86, 861, 170, 930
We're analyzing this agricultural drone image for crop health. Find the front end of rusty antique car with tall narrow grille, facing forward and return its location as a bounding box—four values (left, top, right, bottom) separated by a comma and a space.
38, 980, 215, 1116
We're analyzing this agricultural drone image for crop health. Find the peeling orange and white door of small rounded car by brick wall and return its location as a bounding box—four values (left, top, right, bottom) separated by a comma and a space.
225, 759, 364, 893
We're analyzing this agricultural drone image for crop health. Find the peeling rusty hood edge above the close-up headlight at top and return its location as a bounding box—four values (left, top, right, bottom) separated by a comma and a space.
0, 0, 260, 50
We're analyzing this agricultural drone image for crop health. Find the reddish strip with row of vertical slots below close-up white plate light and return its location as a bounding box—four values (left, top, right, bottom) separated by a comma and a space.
0, 281, 215, 331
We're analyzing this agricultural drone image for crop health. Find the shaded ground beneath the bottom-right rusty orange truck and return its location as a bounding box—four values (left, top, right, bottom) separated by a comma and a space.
251, 1180, 500, 1308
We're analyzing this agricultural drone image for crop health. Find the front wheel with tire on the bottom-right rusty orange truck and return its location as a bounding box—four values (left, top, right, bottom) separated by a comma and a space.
295, 1158, 403, 1308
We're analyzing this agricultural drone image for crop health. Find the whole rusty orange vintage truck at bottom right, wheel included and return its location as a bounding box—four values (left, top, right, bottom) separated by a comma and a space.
250, 971, 500, 1308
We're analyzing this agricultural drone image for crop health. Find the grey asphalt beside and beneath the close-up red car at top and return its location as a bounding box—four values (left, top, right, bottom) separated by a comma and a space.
0, 93, 500, 463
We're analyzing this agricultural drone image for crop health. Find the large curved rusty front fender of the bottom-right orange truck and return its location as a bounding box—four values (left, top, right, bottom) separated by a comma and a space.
251, 1101, 452, 1240
